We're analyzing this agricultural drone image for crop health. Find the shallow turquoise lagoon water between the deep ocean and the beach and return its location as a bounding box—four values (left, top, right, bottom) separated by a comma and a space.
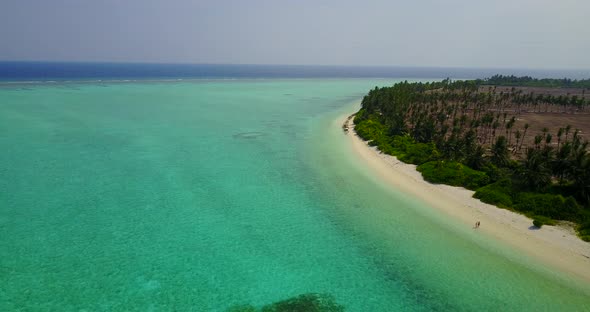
0, 79, 590, 311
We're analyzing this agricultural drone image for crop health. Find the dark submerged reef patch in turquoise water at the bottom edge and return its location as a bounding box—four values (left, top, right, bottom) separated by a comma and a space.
227, 294, 344, 312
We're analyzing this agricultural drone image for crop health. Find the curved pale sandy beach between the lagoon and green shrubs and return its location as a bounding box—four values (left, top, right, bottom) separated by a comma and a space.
339, 116, 590, 283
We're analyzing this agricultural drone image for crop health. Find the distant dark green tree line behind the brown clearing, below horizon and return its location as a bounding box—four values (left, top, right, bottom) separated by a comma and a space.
477, 75, 590, 88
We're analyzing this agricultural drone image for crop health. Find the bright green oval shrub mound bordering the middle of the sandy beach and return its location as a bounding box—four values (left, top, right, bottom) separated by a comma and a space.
417, 161, 490, 190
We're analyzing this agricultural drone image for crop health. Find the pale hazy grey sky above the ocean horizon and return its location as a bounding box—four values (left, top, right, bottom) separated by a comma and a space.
0, 0, 590, 69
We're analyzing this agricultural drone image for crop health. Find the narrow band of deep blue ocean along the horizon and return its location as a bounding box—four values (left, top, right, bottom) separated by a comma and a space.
0, 62, 590, 81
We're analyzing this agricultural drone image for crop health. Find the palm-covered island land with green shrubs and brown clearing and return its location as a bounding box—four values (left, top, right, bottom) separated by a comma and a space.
352, 75, 590, 241
